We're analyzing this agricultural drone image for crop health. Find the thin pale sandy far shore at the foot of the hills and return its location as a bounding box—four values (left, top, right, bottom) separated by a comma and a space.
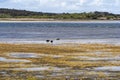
0, 18, 120, 23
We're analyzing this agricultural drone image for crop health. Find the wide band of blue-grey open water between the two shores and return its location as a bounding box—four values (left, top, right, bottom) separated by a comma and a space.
0, 22, 120, 43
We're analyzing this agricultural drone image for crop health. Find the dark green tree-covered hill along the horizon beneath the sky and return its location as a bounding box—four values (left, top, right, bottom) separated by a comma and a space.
0, 8, 120, 20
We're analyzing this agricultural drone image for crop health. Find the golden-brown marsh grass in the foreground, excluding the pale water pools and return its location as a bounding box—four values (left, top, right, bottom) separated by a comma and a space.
0, 44, 120, 80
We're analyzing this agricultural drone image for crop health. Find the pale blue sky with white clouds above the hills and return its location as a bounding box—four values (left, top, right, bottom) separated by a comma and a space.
0, 0, 120, 14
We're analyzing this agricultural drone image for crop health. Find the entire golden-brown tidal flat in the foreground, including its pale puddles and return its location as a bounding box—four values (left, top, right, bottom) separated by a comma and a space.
0, 43, 120, 80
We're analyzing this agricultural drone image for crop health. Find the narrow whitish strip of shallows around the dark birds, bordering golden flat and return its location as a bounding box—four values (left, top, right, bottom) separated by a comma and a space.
0, 39, 120, 45
